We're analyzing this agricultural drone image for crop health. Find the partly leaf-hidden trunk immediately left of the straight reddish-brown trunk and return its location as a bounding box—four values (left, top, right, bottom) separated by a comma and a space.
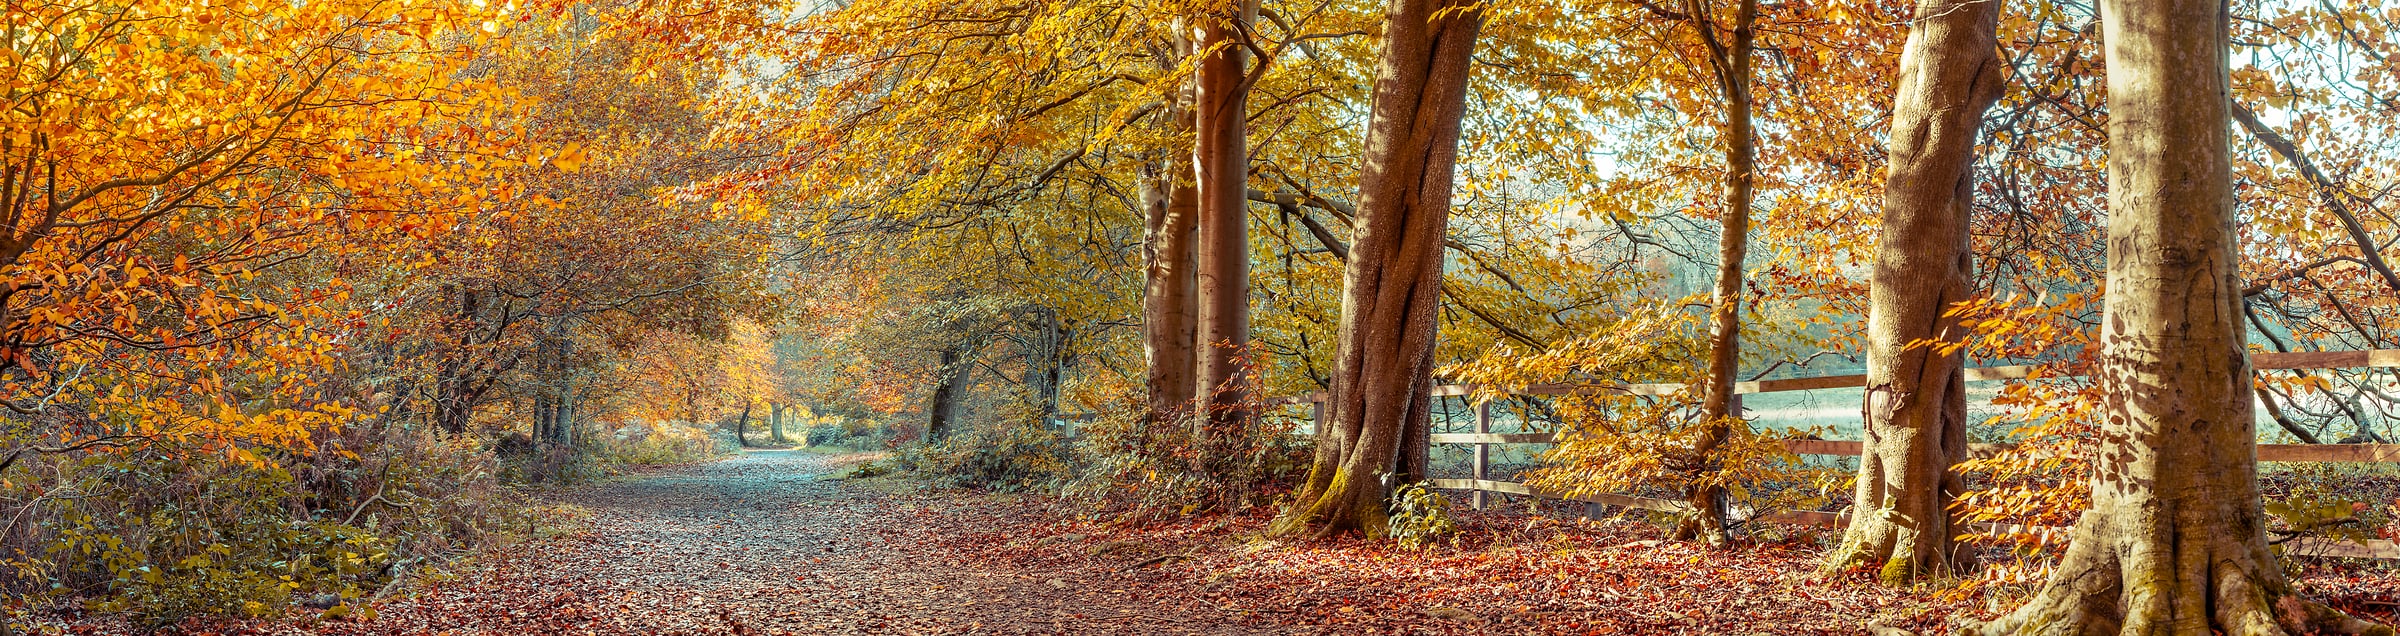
1142, 36, 1200, 422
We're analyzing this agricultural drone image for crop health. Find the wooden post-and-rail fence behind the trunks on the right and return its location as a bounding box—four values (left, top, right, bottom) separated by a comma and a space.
1286, 350, 2400, 559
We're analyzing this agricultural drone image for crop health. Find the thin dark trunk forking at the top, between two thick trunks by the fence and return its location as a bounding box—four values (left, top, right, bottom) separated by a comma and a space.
1675, 0, 1759, 545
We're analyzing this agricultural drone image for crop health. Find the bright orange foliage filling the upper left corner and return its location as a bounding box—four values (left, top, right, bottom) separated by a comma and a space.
0, 0, 530, 456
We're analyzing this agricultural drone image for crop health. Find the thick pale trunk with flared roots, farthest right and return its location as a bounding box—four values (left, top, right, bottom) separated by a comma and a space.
1975, 0, 2393, 636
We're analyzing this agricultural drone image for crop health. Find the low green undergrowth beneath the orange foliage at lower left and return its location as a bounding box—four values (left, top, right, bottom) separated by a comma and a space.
0, 417, 523, 629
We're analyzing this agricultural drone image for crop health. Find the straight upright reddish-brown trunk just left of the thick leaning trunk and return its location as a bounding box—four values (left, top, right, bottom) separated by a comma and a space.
1193, 2, 1255, 429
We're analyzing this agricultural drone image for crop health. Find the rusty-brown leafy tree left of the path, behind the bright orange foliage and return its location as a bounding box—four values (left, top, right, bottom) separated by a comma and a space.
379, 9, 780, 444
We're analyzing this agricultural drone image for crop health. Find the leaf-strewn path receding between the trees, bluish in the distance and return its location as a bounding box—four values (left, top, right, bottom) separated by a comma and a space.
343, 451, 1255, 636
